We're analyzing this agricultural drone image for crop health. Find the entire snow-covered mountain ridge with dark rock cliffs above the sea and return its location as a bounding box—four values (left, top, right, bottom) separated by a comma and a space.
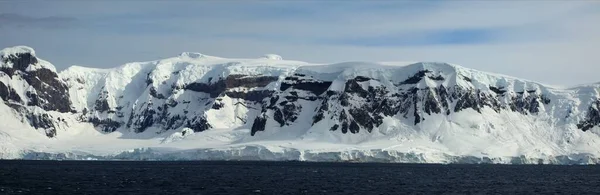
0, 46, 600, 164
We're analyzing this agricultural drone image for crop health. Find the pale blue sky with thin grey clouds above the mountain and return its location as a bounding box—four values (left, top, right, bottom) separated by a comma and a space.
0, 0, 600, 86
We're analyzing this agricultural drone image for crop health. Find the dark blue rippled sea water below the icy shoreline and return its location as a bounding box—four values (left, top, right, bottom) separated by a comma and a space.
0, 161, 600, 194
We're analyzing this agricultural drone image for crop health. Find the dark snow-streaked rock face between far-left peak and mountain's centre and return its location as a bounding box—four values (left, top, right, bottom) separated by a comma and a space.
88, 74, 278, 133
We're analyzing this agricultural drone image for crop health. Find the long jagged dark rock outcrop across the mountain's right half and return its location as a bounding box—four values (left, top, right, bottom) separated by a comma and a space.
253, 70, 550, 134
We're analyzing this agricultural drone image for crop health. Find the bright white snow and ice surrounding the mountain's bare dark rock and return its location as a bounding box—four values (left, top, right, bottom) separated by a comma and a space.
0, 46, 600, 164
